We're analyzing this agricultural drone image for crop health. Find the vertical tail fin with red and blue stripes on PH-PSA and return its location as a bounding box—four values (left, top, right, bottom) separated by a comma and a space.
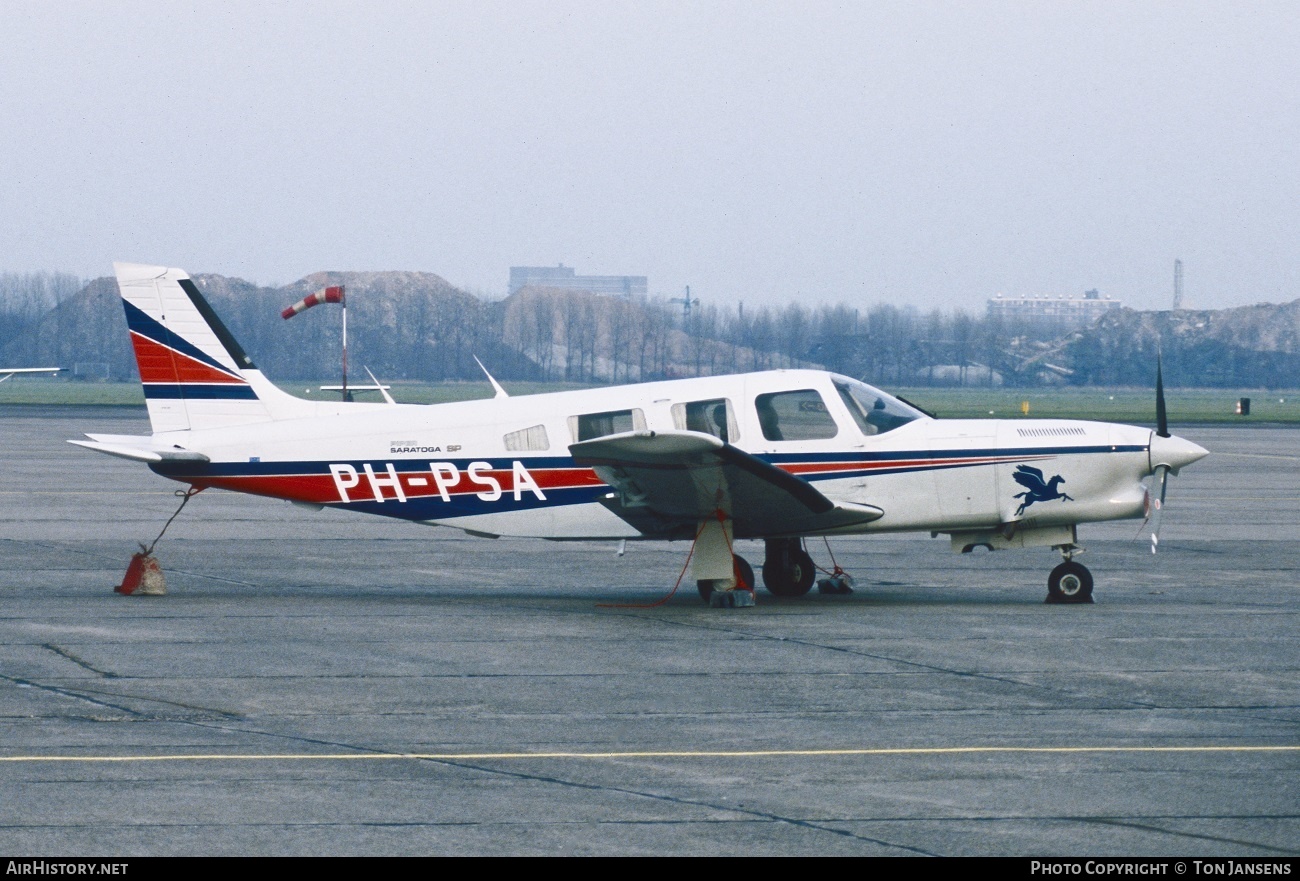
113, 262, 315, 434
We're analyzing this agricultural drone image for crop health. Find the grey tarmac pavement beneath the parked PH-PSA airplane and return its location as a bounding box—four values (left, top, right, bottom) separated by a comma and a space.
0, 407, 1300, 858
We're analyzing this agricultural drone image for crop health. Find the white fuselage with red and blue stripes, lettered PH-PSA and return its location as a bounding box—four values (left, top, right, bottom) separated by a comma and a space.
144, 370, 1170, 539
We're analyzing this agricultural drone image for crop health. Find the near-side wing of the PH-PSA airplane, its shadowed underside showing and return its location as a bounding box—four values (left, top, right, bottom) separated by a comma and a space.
569, 431, 884, 538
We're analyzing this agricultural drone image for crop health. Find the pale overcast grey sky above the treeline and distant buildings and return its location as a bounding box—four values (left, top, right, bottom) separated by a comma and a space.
0, 0, 1300, 309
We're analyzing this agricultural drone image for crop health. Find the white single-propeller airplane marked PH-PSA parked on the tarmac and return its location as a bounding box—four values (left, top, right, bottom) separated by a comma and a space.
70, 264, 1206, 604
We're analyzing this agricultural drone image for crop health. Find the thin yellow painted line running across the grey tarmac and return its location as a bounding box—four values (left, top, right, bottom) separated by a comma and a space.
0, 746, 1300, 763
